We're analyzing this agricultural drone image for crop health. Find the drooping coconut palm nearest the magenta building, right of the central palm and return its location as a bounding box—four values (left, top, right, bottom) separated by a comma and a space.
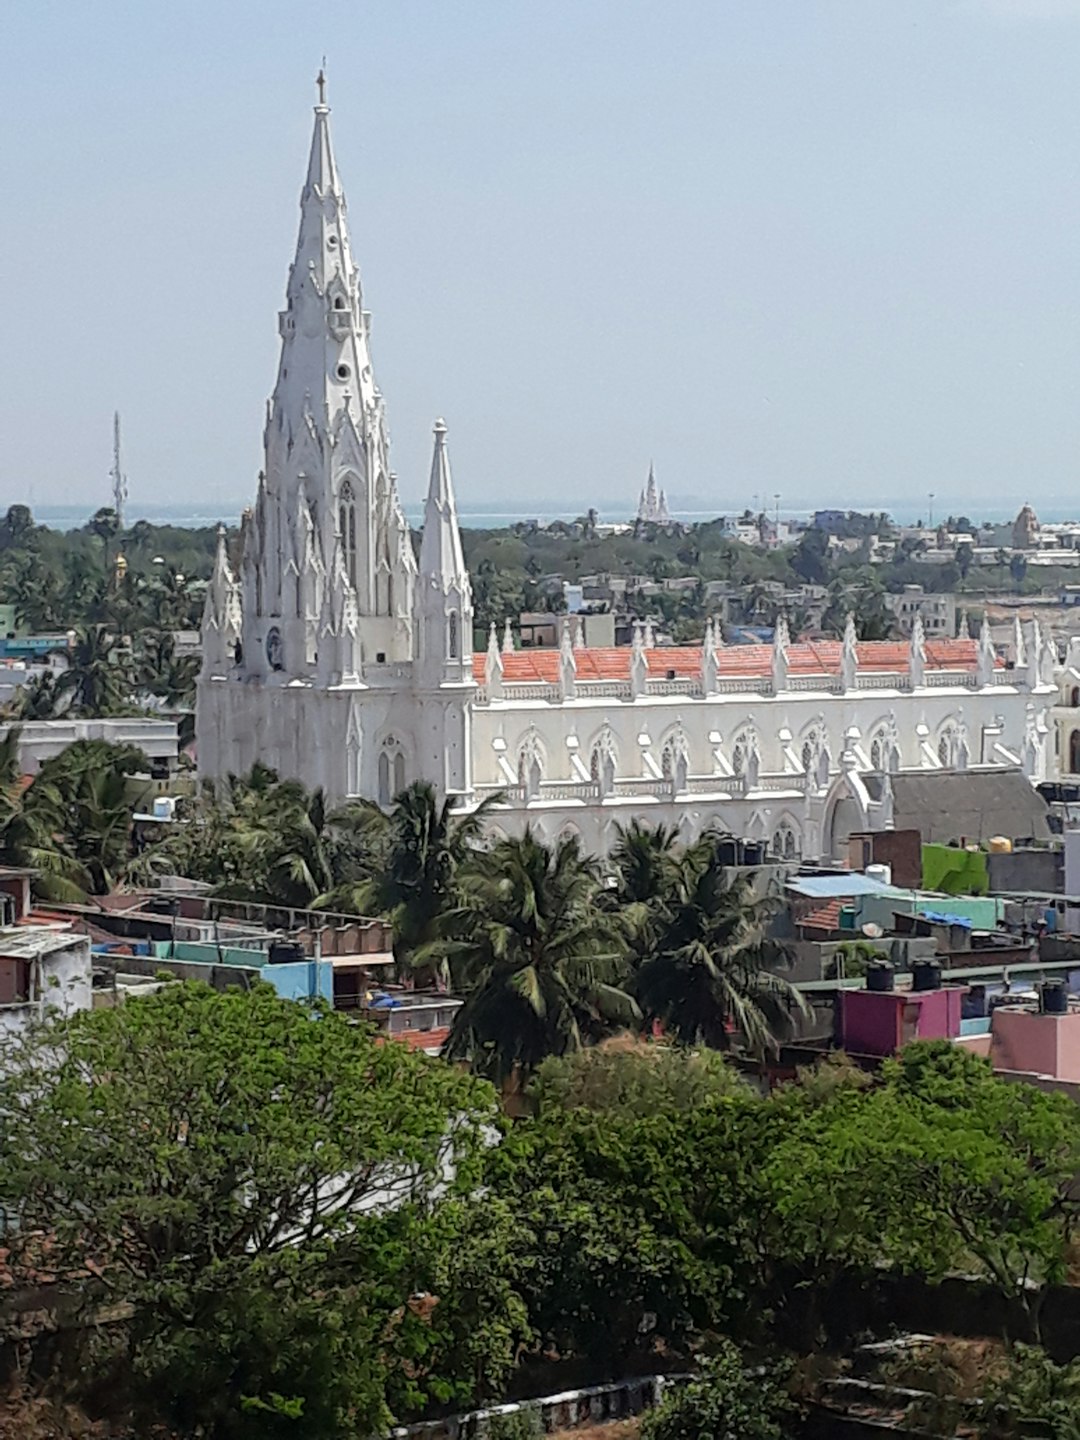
634, 837, 806, 1056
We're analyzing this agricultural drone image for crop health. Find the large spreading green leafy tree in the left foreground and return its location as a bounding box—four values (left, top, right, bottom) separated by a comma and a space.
0, 984, 512, 1436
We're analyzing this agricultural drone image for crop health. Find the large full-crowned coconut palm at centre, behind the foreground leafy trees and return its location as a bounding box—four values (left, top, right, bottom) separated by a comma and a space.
444, 829, 639, 1084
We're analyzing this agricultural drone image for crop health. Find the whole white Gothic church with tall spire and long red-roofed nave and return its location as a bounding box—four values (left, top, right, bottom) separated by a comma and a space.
197, 95, 1058, 858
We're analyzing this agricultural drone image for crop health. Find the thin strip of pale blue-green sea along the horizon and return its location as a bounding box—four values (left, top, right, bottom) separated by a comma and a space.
16, 494, 1080, 530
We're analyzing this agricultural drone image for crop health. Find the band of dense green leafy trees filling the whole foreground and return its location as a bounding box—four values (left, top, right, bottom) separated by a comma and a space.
0, 1002, 1080, 1440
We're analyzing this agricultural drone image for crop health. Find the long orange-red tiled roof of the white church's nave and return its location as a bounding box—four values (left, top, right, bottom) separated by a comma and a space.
472, 639, 1002, 684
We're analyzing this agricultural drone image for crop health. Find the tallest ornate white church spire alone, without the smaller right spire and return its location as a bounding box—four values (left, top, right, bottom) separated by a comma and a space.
243, 76, 416, 684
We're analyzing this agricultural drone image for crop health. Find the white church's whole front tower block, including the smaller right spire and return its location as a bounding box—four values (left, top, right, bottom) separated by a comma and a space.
197, 75, 475, 804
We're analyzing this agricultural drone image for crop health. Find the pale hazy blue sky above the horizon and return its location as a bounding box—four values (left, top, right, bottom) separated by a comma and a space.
0, 0, 1080, 513
